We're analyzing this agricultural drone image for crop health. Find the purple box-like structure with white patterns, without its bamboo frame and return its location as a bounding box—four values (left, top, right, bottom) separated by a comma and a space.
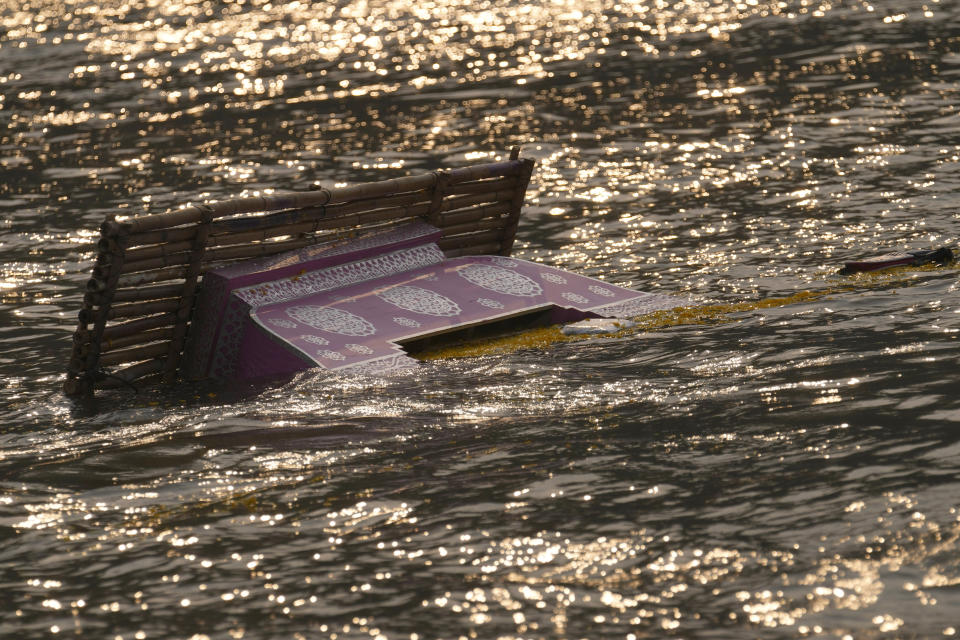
185, 222, 677, 381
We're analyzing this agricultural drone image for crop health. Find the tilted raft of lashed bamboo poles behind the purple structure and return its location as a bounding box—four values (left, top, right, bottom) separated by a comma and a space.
64, 148, 534, 396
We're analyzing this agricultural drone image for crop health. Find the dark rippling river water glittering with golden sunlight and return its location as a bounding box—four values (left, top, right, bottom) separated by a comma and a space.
0, 0, 960, 640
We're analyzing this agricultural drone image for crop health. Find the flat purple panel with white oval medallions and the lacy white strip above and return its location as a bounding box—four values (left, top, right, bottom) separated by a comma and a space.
235, 251, 677, 380
